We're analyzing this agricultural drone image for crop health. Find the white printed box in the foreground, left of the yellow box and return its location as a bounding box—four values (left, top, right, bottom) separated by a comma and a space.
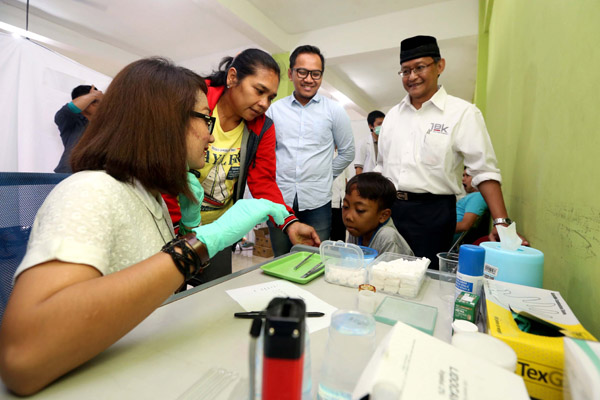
352, 322, 529, 400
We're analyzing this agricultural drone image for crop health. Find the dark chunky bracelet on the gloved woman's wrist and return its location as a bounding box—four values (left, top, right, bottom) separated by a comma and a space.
160, 235, 209, 282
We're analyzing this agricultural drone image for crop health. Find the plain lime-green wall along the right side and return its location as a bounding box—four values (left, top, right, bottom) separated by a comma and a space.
476, 0, 600, 339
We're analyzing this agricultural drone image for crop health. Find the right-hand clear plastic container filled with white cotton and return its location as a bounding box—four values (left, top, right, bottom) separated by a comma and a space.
369, 253, 430, 299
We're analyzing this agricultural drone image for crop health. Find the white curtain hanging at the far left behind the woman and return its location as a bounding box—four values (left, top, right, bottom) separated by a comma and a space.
0, 33, 111, 172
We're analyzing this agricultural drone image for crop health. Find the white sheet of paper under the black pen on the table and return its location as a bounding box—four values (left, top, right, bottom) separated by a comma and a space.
227, 280, 337, 333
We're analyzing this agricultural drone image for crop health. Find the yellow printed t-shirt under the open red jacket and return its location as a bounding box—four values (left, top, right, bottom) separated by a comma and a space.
198, 107, 244, 225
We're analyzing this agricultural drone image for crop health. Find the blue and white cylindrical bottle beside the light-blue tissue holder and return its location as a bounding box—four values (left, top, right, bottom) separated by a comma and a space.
454, 244, 485, 299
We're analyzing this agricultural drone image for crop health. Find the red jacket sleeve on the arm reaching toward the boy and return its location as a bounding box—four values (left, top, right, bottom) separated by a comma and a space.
248, 120, 297, 230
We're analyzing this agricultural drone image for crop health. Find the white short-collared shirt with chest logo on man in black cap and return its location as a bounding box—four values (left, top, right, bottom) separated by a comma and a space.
375, 86, 501, 195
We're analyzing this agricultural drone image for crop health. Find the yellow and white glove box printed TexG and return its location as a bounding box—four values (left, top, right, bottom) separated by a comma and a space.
483, 279, 596, 400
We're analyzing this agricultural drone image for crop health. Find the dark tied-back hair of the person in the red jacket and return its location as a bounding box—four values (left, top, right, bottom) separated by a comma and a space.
207, 49, 281, 86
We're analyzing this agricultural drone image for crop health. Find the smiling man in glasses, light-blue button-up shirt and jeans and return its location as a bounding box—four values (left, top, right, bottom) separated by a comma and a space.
267, 45, 354, 257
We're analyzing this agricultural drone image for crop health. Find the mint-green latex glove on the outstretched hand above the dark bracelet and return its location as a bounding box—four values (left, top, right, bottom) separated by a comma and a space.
192, 199, 290, 258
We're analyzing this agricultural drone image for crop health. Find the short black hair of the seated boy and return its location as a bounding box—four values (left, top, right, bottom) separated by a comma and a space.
346, 172, 396, 211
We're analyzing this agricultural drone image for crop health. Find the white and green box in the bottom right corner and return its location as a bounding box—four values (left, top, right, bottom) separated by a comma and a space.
563, 338, 600, 400
